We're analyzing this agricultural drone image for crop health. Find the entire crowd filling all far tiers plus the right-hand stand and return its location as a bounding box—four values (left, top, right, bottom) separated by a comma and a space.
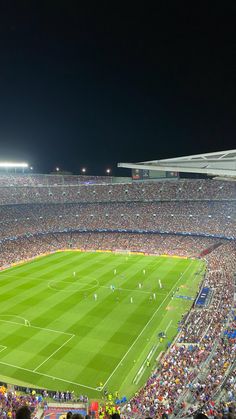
0, 175, 236, 419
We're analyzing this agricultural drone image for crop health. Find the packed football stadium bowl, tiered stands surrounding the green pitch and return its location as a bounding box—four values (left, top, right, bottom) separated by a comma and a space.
0, 155, 236, 418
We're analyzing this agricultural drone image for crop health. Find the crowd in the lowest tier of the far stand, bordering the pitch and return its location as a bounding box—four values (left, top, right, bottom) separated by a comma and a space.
0, 233, 232, 268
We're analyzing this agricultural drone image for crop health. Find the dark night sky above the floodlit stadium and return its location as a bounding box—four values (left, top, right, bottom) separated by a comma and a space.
0, 0, 236, 174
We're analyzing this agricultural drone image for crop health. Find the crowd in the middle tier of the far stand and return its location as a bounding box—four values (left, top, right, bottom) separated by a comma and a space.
0, 201, 236, 243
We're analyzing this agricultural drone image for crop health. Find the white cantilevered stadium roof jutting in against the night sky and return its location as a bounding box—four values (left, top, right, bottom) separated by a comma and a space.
118, 150, 236, 177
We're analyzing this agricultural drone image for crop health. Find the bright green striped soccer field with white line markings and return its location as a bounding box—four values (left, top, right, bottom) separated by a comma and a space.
0, 251, 204, 398
